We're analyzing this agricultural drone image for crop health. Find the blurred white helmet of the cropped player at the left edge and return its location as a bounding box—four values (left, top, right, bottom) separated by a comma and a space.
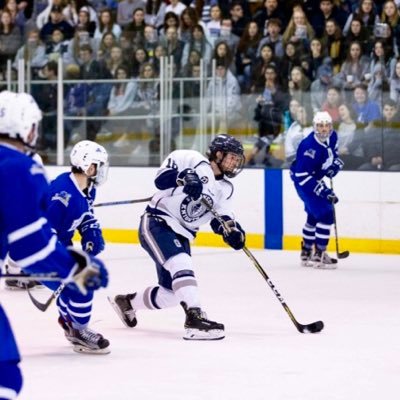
0, 90, 42, 148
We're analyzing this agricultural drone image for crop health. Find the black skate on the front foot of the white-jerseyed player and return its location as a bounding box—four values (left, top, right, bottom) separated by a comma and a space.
181, 301, 225, 340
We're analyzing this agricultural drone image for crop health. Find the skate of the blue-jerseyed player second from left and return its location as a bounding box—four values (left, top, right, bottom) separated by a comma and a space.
58, 317, 110, 354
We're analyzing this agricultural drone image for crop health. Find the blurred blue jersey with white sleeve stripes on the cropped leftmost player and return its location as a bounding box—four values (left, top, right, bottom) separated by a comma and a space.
0, 144, 75, 361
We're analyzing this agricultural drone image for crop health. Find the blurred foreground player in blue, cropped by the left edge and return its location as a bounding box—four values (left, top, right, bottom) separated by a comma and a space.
0, 91, 108, 400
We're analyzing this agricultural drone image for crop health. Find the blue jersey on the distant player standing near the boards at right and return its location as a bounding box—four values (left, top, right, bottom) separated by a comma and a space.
290, 131, 338, 193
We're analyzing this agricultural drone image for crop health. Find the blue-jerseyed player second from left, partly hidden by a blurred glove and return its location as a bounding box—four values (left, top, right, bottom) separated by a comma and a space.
46, 140, 109, 353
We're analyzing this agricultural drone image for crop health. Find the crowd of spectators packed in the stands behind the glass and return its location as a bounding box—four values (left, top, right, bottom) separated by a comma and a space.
0, 0, 400, 170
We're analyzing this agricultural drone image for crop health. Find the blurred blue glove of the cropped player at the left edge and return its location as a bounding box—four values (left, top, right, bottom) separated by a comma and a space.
68, 247, 108, 294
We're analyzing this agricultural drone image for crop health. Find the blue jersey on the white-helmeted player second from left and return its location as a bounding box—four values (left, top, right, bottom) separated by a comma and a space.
47, 172, 97, 246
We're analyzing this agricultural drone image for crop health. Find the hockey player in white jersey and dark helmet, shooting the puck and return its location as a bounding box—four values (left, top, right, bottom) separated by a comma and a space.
110, 134, 245, 340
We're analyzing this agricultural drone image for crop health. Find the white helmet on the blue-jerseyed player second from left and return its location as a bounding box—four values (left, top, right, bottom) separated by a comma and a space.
70, 140, 108, 185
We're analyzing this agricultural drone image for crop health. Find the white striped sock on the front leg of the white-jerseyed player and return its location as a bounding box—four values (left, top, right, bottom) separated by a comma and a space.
164, 253, 200, 308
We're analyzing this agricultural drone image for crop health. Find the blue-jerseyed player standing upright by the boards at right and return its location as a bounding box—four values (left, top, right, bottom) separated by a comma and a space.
291, 111, 343, 269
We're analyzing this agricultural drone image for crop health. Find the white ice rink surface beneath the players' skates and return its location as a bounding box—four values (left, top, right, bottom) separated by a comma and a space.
0, 245, 400, 400
